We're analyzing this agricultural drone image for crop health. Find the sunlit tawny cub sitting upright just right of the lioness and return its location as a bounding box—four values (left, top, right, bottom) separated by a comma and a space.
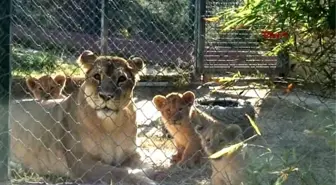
153, 91, 202, 167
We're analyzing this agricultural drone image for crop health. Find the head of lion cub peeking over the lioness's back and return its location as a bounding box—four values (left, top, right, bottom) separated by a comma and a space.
26, 75, 66, 101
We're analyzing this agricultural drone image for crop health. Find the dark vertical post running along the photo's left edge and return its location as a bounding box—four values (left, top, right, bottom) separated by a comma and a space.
0, 0, 12, 184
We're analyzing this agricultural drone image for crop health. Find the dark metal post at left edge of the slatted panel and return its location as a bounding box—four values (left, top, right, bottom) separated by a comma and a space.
195, 0, 206, 76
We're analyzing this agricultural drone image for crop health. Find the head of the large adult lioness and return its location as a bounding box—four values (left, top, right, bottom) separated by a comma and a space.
78, 51, 144, 119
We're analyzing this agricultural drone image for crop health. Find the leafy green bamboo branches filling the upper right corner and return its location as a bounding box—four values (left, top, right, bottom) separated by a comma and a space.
212, 0, 336, 87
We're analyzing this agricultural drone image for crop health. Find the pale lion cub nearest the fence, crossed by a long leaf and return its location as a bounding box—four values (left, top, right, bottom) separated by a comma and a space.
195, 123, 245, 185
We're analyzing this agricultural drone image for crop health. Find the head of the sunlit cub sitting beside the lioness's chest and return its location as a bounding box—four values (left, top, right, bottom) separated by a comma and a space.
153, 91, 195, 125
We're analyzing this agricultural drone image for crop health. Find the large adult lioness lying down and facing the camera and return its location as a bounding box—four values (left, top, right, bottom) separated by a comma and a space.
10, 50, 156, 185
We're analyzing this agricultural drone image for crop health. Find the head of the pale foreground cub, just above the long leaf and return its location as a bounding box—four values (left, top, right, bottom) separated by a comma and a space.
195, 123, 243, 155
